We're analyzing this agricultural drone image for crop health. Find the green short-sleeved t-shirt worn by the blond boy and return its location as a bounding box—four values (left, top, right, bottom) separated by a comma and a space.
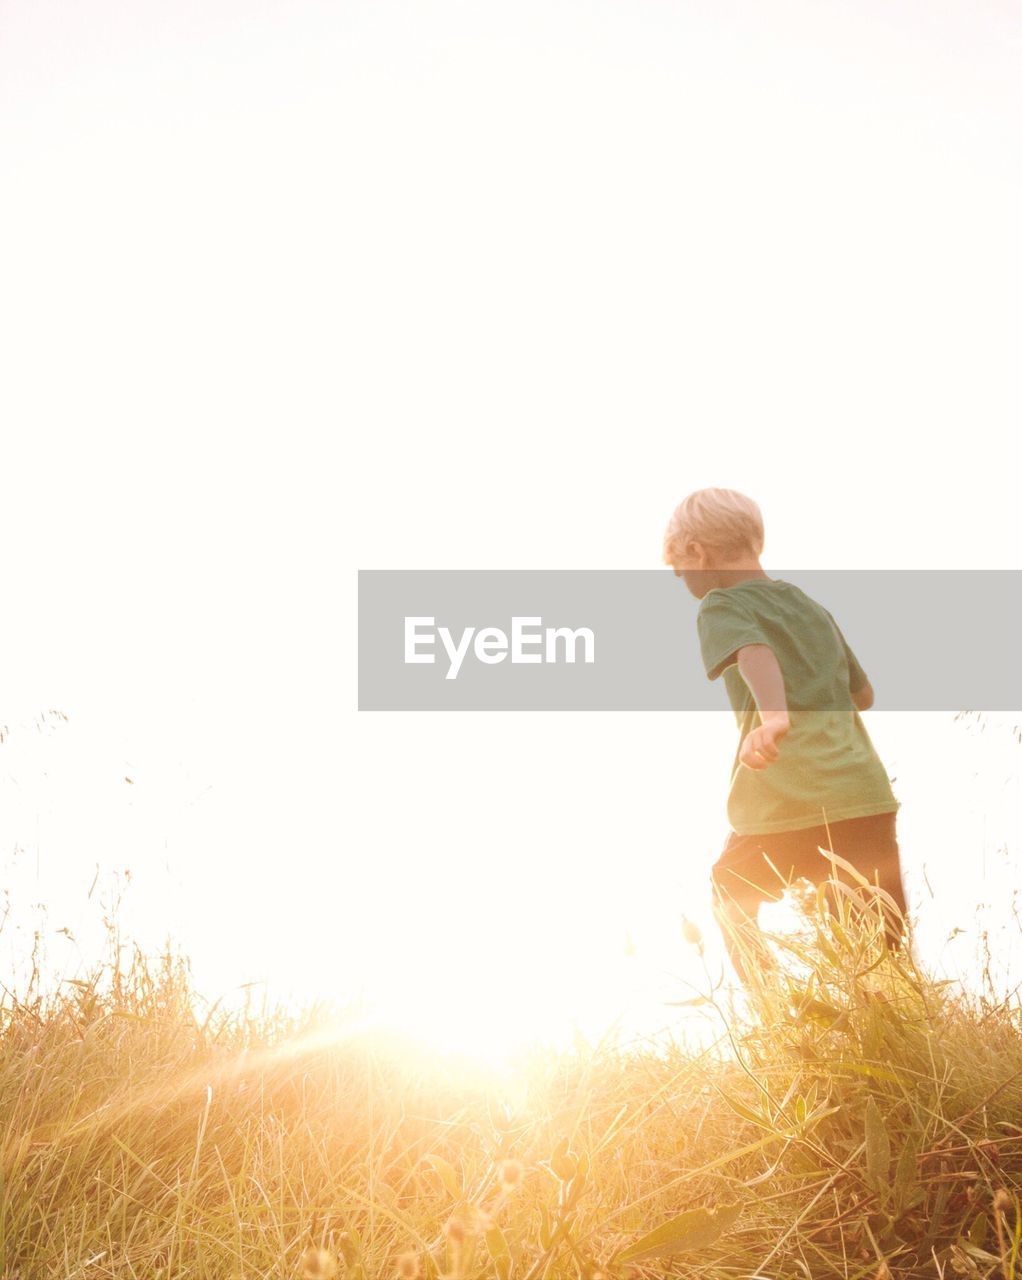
698, 577, 898, 836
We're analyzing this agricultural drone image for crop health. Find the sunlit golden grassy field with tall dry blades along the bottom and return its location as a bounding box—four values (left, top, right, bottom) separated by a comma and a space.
0, 890, 1022, 1280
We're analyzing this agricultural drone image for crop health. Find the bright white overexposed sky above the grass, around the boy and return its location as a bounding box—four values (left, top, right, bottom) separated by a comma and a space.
0, 0, 1022, 1044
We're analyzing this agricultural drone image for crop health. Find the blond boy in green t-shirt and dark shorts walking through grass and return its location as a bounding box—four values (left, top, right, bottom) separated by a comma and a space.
663, 489, 905, 980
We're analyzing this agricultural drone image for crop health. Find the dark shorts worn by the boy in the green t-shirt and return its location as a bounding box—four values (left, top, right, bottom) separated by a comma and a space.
713, 813, 905, 914
